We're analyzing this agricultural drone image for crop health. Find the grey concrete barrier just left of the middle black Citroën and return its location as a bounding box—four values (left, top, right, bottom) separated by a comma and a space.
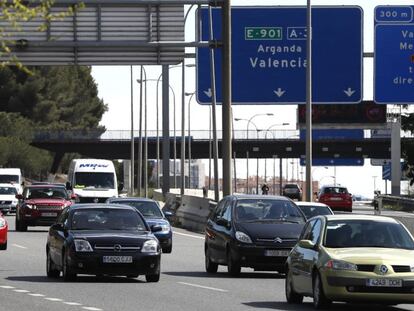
176, 195, 216, 232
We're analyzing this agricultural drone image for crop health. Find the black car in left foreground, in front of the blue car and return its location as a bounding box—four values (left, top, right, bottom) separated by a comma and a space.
46, 204, 161, 282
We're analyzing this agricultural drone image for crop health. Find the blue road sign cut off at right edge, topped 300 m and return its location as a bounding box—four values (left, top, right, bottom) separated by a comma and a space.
374, 6, 414, 104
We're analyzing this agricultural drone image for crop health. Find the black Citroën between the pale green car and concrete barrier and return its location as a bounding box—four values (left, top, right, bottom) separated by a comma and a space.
204, 195, 306, 276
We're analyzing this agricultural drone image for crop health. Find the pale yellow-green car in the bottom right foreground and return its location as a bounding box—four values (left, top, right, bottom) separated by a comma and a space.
285, 215, 414, 309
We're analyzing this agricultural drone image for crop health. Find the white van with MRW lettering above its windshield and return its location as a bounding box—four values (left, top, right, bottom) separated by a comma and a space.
67, 159, 118, 203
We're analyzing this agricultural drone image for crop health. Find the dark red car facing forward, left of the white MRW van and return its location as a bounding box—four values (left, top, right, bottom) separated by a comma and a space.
16, 184, 74, 231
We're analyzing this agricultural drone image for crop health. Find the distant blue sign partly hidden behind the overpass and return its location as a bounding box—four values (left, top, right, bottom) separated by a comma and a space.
299, 129, 364, 166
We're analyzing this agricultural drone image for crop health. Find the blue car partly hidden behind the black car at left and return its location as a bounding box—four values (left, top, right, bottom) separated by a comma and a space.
107, 198, 172, 253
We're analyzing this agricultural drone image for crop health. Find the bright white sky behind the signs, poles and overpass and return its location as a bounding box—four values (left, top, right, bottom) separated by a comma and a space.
92, 0, 413, 197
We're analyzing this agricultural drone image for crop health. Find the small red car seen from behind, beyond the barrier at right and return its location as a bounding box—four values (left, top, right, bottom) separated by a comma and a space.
318, 185, 352, 212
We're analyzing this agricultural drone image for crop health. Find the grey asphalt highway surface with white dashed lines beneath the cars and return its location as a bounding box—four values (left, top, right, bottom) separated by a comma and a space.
0, 215, 414, 311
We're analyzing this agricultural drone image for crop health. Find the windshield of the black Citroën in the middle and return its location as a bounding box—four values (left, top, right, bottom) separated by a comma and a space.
235, 199, 304, 223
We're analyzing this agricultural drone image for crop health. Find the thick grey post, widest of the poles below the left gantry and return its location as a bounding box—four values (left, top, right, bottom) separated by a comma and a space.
162, 65, 170, 197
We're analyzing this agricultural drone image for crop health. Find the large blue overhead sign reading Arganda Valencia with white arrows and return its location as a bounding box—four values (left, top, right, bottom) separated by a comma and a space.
197, 6, 363, 104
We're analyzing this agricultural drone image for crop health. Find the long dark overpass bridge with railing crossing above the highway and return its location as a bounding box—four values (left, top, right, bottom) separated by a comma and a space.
31, 130, 414, 172
